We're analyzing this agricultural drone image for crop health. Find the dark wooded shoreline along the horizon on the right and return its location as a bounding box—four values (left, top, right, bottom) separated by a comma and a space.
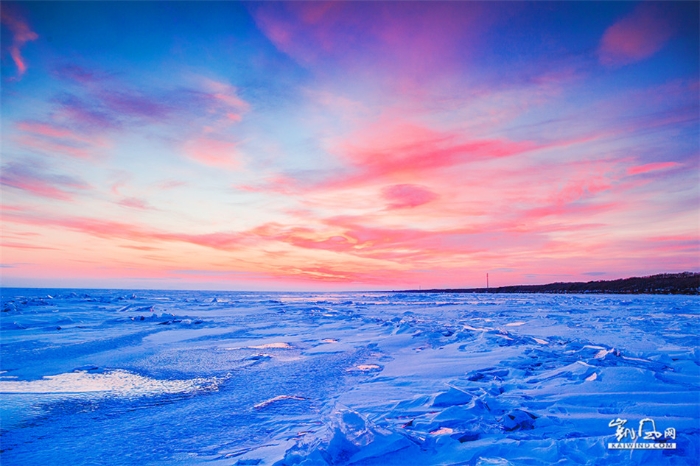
401, 272, 700, 295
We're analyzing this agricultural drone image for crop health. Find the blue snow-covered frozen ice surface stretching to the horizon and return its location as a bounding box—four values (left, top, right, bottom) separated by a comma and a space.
0, 288, 700, 466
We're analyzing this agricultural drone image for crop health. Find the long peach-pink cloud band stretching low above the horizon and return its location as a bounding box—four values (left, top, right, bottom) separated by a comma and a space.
3, 201, 698, 287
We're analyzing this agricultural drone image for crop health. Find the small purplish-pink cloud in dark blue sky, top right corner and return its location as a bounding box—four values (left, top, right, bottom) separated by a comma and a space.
598, 2, 674, 65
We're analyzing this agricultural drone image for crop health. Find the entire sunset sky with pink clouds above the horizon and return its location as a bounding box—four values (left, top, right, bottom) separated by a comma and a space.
0, 1, 700, 291
